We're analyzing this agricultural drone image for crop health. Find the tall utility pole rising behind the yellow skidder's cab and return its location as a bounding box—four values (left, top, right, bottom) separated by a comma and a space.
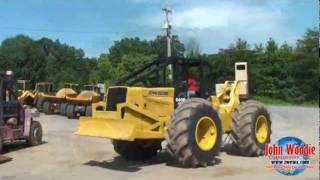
162, 8, 172, 84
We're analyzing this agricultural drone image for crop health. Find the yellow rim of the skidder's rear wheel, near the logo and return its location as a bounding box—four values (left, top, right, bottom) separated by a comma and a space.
255, 115, 269, 144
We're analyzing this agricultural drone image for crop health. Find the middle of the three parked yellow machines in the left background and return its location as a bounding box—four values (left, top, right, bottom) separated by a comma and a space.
41, 83, 79, 114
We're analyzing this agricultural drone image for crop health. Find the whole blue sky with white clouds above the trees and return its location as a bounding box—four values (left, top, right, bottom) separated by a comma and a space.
0, 0, 319, 57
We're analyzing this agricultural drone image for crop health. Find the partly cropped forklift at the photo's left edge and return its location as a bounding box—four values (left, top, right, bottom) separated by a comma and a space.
0, 71, 42, 160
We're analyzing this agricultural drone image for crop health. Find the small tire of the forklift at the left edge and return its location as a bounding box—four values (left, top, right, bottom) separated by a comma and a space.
27, 121, 42, 146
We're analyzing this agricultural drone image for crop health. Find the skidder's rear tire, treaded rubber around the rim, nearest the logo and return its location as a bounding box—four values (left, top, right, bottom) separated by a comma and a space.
231, 100, 271, 156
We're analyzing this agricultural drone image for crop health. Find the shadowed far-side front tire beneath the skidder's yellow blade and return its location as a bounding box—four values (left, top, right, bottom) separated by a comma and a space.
112, 140, 161, 161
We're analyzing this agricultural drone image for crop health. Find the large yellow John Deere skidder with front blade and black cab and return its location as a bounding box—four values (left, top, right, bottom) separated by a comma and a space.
76, 58, 271, 167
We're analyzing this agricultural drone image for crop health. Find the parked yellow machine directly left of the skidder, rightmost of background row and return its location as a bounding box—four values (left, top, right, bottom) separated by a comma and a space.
60, 85, 103, 119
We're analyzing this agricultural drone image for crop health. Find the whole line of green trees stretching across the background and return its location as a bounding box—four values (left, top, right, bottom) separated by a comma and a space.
0, 28, 319, 103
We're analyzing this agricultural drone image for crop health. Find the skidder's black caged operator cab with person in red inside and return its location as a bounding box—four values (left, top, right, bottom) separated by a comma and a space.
115, 57, 214, 106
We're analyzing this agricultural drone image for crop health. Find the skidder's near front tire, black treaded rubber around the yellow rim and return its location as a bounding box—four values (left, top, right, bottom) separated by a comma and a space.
166, 98, 222, 167
